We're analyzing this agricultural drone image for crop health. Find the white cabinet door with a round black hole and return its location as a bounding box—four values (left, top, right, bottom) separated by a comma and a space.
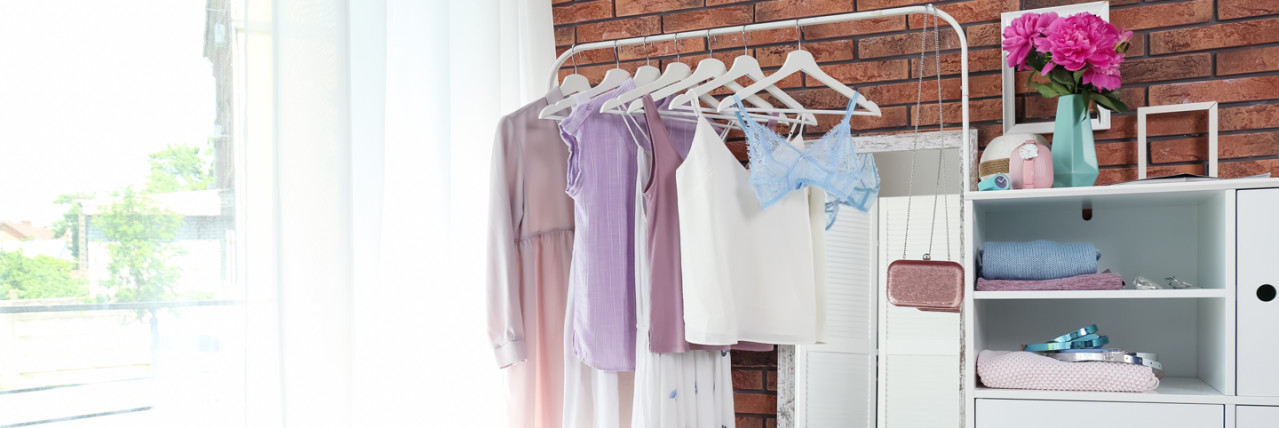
1237, 189, 1279, 398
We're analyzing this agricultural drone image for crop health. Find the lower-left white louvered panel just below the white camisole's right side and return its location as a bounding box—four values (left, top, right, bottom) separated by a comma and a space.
806, 351, 875, 428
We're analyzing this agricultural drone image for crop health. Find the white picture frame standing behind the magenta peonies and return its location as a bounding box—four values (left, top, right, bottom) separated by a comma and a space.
999, 1, 1110, 134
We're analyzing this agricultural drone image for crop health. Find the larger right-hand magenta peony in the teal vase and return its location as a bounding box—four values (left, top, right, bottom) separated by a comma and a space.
1036, 13, 1123, 74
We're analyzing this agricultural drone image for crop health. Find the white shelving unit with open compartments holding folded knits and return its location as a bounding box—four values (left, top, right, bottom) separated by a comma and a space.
964, 179, 1279, 428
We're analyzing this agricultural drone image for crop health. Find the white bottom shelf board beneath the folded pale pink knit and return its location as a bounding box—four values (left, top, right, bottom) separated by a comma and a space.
973, 377, 1238, 404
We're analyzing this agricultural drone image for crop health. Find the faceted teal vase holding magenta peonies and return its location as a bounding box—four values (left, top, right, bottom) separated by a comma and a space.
1053, 95, 1097, 188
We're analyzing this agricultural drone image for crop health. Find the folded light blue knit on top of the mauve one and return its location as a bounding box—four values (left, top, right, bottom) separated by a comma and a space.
981, 240, 1101, 281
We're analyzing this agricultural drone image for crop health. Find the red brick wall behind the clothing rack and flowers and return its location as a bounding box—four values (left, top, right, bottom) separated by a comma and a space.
553, 0, 1279, 428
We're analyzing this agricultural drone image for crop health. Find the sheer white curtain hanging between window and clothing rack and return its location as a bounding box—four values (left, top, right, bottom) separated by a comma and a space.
242, 0, 554, 428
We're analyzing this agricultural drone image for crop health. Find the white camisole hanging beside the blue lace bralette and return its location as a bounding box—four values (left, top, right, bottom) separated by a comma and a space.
675, 112, 825, 345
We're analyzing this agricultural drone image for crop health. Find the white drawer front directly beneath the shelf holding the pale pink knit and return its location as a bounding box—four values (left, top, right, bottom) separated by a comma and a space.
976, 400, 1217, 428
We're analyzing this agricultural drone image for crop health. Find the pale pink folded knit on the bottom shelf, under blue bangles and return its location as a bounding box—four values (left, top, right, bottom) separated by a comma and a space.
977, 350, 1159, 392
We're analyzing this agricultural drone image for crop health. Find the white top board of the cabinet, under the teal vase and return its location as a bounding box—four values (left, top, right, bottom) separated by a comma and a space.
964, 178, 1279, 204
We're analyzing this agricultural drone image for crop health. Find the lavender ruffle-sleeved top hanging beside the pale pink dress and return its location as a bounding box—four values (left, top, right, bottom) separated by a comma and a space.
560, 80, 636, 372
